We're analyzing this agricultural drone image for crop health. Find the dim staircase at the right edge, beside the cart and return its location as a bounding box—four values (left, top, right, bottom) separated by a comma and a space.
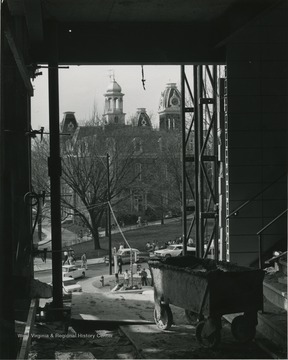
257, 252, 288, 359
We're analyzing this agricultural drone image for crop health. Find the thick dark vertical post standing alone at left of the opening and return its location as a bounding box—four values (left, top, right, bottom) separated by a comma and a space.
48, 22, 63, 310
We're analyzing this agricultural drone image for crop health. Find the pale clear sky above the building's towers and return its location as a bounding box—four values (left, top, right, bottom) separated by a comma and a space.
31, 65, 180, 130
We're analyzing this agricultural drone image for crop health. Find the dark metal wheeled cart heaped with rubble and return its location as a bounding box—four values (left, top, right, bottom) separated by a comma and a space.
148, 256, 264, 348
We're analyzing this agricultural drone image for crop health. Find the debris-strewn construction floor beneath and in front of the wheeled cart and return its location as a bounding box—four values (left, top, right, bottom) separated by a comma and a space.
29, 277, 271, 360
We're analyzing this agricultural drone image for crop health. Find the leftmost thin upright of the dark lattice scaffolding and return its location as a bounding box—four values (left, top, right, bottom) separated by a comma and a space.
181, 65, 187, 255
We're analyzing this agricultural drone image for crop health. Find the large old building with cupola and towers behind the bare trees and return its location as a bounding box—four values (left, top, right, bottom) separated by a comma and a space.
61, 76, 181, 225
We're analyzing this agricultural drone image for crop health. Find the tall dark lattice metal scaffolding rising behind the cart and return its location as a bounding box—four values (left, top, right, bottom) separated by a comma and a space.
181, 65, 226, 260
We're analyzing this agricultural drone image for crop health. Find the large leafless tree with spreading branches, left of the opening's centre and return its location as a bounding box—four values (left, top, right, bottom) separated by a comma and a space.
62, 126, 140, 249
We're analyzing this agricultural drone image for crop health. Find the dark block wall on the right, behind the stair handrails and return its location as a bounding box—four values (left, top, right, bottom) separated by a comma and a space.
227, 2, 288, 265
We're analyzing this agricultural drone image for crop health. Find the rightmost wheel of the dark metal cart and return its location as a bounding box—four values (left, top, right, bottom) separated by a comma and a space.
231, 315, 256, 343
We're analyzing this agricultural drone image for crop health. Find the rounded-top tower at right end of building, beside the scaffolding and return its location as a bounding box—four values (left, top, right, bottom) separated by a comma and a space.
158, 83, 181, 130
